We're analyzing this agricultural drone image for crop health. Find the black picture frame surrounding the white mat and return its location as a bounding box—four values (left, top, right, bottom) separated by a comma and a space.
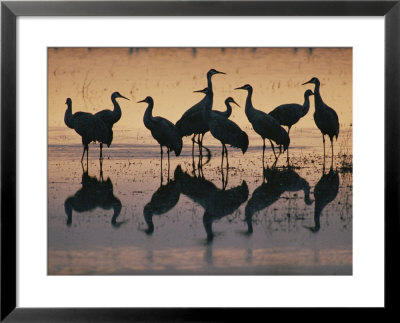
0, 0, 400, 322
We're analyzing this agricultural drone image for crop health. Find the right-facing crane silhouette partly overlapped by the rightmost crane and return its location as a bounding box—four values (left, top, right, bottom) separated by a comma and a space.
269, 90, 314, 162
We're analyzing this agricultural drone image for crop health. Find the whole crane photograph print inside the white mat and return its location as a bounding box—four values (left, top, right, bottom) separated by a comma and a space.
47, 47, 353, 275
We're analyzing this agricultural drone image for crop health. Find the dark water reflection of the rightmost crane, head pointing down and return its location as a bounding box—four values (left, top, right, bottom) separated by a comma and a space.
307, 167, 339, 232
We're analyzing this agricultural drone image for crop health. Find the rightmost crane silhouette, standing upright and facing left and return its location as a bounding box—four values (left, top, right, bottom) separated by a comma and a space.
303, 77, 339, 165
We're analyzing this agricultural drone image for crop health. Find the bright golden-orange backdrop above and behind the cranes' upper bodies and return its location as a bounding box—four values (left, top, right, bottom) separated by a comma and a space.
48, 48, 352, 130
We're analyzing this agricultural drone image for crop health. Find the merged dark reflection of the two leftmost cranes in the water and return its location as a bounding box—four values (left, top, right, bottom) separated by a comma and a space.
64, 162, 124, 228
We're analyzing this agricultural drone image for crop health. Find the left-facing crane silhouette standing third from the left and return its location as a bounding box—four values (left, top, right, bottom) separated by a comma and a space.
138, 96, 182, 169
